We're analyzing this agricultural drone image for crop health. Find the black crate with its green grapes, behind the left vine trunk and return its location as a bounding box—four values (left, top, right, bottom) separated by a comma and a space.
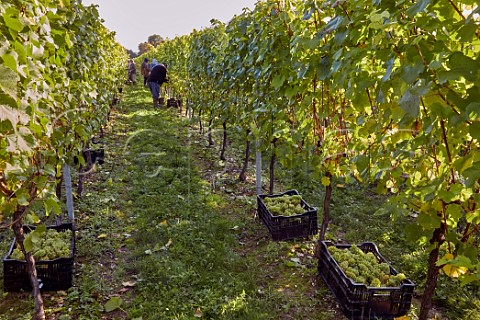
3, 223, 75, 292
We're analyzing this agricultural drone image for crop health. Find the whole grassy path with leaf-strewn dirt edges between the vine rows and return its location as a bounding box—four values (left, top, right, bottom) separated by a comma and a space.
0, 86, 342, 320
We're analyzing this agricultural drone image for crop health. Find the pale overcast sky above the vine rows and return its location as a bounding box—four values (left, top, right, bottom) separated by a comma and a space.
82, 0, 257, 52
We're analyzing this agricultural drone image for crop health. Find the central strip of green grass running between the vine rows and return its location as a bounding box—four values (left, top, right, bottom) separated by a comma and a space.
119, 86, 296, 319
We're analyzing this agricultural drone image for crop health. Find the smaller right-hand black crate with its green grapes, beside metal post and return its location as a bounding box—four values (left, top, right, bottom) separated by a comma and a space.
257, 190, 318, 241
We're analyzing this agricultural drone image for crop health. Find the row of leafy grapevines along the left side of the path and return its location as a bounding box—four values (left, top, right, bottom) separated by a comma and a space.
0, 0, 126, 319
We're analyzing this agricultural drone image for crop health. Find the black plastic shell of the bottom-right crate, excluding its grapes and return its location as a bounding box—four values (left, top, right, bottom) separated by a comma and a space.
318, 241, 415, 320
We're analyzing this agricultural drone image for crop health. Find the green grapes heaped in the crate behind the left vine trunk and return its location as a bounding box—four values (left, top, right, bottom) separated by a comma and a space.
10, 229, 72, 261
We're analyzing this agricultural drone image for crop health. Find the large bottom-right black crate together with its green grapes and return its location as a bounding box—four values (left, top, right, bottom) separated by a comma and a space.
318, 241, 415, 320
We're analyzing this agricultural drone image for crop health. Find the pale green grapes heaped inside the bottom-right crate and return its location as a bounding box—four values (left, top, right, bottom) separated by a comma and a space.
328, 245, 407, 288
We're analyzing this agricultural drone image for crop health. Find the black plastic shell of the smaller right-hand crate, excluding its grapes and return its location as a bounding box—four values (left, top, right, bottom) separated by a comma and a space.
257, 190, 318, 241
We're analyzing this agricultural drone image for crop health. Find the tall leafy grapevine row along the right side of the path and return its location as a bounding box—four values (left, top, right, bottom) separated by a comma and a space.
151, 0, 480, 319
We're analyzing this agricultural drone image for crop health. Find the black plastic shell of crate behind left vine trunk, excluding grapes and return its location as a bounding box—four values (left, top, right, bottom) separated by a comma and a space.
3, 223, 75, 292
